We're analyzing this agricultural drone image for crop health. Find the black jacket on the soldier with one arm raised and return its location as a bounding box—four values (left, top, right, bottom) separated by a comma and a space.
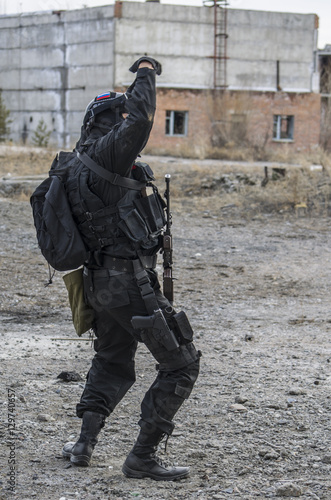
67, 68, 157, 266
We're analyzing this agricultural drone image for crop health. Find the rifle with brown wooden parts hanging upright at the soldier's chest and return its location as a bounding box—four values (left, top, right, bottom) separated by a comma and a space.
162, 174, 174, 304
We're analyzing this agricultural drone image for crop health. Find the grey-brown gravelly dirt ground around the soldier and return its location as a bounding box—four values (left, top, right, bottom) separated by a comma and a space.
0, 148, 331, 500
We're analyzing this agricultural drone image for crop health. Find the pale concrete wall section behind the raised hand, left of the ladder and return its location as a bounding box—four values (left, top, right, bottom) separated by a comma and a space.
115, 2, 214, 89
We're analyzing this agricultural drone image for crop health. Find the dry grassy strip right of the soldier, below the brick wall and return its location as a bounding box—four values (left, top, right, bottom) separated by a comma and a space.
156, 161, 331, 217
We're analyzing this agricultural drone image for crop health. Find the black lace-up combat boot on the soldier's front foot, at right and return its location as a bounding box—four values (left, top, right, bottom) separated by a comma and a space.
122, 431, 189, 481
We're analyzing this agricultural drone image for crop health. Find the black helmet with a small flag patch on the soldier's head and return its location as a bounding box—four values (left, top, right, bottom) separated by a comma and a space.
83, 92, 128, 130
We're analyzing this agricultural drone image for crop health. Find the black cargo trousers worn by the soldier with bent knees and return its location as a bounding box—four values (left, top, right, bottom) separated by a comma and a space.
77, 269, 200, 435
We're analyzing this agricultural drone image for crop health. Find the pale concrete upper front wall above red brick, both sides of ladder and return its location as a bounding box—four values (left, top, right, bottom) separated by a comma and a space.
115, 2, 318, 92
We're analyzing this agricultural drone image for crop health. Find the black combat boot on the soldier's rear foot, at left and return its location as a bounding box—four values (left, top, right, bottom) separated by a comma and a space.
62, 411, 105, 467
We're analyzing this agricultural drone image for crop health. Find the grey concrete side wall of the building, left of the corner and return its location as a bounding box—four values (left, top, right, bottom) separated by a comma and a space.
0, 6, 114, 147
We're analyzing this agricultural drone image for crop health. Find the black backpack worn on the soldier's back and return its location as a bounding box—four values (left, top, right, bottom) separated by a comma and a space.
30, 152, 88, 271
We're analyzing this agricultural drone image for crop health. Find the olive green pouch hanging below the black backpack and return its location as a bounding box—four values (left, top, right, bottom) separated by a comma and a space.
63, 267, 94, 337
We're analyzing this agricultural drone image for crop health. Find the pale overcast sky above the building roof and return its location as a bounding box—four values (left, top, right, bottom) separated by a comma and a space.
0, 0, 331, 49
